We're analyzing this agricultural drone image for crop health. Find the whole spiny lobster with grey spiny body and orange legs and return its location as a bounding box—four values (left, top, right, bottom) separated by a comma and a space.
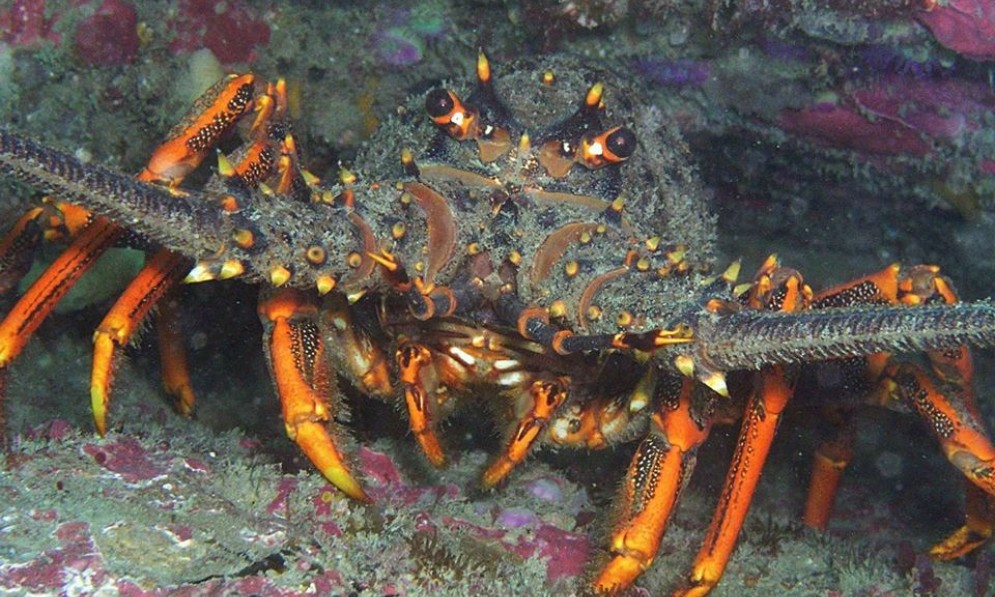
0, 54, 995, 595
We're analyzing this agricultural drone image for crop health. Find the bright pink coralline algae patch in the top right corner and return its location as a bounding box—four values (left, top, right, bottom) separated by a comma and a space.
917, 0, 995, 60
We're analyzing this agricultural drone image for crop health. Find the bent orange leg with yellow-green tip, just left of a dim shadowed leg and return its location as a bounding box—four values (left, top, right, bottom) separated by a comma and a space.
90, 249, 189, 435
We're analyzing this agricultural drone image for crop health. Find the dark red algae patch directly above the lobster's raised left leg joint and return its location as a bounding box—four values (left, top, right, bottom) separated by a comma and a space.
169, 0, 270, 64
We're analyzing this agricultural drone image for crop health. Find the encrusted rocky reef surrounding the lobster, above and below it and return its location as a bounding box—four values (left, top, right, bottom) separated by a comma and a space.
0, 0, 995, 596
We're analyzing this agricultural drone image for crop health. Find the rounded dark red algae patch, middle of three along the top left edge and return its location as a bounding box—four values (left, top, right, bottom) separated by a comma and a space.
74, 0, 139, 66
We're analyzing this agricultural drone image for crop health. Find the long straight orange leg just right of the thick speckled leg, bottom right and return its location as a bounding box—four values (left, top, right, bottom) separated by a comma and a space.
678, 367, 794, 595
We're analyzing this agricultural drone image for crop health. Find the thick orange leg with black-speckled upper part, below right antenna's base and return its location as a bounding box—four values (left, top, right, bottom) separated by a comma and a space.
592, 379, 711, 593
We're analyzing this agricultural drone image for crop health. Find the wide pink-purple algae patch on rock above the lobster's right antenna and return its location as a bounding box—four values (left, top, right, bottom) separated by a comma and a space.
778, 76, 992, 157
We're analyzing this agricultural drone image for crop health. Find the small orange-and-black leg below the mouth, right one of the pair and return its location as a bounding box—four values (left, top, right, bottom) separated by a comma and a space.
481, 378, 570, 488
